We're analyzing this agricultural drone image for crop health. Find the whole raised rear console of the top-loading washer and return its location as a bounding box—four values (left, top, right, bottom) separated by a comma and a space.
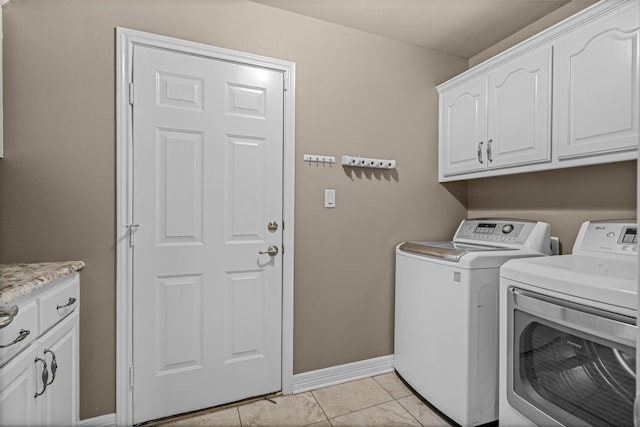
453, 218, 550, 253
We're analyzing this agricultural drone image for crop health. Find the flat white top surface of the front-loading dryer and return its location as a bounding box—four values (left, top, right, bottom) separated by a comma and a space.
500, 254, 638, 310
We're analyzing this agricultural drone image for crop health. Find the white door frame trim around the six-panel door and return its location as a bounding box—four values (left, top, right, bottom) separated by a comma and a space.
116, 27, 295, 425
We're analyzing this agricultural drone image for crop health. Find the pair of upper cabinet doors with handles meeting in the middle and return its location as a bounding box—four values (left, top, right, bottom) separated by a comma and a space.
440, 47, 551, 178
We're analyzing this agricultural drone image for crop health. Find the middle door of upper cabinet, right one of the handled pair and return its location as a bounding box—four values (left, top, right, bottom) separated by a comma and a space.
487, 47, 551, 168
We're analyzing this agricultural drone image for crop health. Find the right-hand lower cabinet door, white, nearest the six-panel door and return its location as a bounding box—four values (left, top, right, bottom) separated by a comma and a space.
37, 310, 79, 426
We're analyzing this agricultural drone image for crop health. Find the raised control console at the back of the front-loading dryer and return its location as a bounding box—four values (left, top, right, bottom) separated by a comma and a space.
573, 221, 638, 255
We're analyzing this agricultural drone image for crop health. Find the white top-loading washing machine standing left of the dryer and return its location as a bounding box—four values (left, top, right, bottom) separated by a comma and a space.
394, 219, 550, 426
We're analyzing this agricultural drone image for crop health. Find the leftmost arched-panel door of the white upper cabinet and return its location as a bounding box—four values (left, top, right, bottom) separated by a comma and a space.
440, 77, 487, 176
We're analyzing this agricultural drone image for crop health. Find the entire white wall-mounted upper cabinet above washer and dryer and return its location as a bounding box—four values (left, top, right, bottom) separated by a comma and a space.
437, 0, 640, 181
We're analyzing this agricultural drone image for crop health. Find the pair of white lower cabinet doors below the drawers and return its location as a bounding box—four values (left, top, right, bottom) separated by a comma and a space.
0, 310, 79, 426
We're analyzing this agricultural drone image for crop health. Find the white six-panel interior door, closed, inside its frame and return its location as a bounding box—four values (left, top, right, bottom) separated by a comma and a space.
132, 46, 284, 423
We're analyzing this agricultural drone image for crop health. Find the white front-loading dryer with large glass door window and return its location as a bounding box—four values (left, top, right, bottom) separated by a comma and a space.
499, 221, 638, 427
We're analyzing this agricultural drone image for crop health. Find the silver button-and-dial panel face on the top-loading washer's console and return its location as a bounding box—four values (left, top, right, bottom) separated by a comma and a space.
454, 219, 536, 245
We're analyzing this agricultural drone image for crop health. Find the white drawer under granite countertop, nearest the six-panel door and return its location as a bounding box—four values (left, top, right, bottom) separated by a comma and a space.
38, 273, 80, 334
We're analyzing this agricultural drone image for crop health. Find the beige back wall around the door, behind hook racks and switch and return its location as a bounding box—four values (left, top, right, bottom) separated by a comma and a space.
0, 0, 467, 419
